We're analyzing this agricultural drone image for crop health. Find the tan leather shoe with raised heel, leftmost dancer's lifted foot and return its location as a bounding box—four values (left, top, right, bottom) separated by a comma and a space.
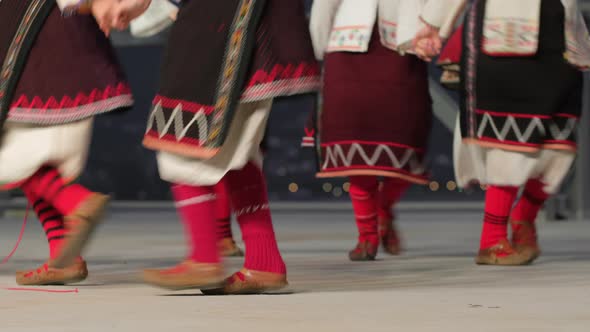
51, 193, 110, 268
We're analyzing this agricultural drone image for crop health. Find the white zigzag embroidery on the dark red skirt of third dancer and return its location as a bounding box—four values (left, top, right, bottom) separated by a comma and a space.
322, 143, 424, 174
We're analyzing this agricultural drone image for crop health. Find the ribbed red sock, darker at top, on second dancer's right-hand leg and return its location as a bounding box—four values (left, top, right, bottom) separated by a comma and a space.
225, 162, 287, 274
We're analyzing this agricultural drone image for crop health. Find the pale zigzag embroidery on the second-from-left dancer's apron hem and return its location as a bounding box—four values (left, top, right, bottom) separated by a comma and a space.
146, 102, 209, 142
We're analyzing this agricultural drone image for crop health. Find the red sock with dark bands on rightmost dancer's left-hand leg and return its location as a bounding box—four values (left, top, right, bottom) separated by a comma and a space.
480, 186, 518, 250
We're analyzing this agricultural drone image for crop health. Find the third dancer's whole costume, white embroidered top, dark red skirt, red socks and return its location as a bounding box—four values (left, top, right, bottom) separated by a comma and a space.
306, 0, 432, 260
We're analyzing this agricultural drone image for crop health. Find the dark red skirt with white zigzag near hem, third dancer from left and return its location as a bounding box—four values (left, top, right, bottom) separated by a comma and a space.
318, 31, 432, 183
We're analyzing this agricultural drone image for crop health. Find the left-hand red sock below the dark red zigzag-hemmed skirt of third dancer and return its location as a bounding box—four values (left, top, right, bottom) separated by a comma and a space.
349, 176, 379, 246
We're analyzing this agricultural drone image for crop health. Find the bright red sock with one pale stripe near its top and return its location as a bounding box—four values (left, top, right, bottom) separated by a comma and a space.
172, 184, 220, 263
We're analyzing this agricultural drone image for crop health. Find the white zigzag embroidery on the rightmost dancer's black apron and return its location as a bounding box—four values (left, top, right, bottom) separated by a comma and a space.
477, 113, 577, 143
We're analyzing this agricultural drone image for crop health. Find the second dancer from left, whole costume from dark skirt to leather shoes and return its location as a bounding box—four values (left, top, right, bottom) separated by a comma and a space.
144, 0, 320, 294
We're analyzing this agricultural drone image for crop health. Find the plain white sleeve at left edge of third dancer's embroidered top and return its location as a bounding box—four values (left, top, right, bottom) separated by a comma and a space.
309, 0, 342, 60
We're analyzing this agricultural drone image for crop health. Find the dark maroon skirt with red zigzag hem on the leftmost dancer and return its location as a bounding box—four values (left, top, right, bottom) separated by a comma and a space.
0, 0, 133, 125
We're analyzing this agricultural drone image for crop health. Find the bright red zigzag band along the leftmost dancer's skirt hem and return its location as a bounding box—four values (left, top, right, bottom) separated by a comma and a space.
11, 83, 131, 111
